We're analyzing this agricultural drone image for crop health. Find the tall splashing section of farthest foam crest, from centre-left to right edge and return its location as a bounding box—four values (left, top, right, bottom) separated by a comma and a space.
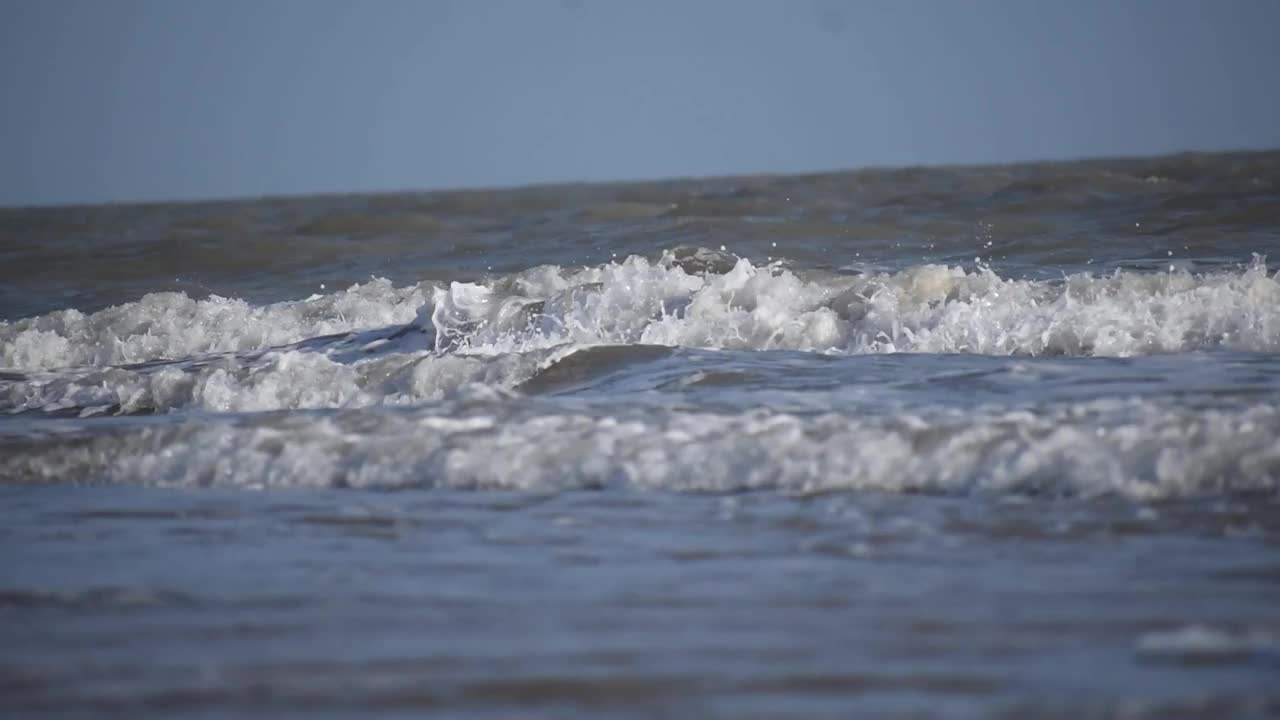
421, 256, 1280, 356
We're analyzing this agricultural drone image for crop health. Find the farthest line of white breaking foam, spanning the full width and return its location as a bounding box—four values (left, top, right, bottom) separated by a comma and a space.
0, 254, 1280, 370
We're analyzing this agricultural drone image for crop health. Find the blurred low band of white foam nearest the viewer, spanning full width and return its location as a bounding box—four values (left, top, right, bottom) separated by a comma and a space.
0, 400, 1280, 498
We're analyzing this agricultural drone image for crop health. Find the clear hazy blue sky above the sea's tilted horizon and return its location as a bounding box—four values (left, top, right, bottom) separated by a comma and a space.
0, 0, 1280, 205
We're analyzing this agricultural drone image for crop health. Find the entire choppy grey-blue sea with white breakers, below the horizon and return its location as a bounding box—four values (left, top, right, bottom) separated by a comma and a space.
0, 152, 1280, 719
